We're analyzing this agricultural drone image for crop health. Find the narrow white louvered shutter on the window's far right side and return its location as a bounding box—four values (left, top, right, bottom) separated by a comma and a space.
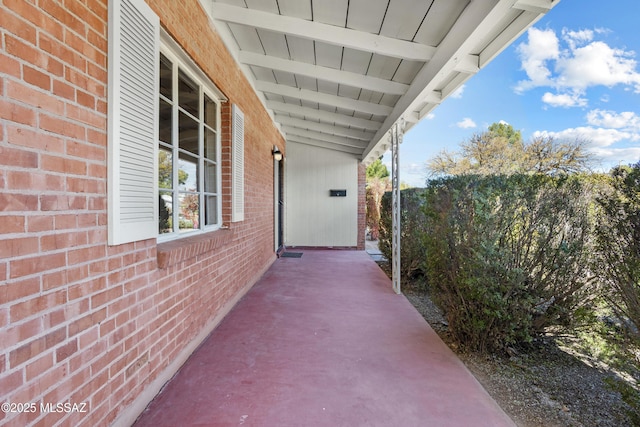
231, 105, 244, 222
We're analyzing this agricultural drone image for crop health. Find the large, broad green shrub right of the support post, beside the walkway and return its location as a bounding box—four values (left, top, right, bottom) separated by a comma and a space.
424, 175, 593, 352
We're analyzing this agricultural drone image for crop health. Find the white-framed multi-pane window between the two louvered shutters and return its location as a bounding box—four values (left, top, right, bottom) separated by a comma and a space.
158, 47, 221, 239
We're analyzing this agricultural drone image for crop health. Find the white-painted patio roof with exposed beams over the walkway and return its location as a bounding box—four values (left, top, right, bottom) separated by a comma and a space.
200, 0, 560, 163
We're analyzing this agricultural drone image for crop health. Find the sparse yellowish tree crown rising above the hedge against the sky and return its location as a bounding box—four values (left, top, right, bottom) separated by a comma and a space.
427, 123, 590, 176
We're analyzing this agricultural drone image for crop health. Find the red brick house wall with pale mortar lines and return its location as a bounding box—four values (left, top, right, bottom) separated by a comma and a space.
0, 0, 284, 426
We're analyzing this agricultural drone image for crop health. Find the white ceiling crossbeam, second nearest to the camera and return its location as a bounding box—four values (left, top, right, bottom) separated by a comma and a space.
238, 51, 409, 95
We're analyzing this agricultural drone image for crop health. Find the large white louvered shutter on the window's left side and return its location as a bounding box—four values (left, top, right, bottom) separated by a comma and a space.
107, 0, 160, 245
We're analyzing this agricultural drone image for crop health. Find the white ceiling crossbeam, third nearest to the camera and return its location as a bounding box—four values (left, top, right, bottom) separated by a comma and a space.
256, 81, 393, 116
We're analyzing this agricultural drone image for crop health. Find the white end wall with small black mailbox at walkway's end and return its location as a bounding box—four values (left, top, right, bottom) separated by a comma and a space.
284, 142, 358, 247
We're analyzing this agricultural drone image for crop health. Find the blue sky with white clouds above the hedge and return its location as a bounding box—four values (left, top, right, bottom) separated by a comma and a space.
392, 0, 640, 186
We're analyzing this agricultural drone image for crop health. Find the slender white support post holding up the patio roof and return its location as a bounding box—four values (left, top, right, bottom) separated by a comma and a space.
390, 119, 404, 294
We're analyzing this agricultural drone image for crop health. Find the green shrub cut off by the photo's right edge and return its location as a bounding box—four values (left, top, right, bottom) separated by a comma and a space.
596, 163, 640, 331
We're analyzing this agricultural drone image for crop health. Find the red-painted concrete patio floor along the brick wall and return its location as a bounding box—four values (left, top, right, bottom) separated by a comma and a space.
136, 250, 514, 427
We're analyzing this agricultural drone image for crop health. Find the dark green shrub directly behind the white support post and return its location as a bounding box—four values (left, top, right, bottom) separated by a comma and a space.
378, 188, 426, 278
